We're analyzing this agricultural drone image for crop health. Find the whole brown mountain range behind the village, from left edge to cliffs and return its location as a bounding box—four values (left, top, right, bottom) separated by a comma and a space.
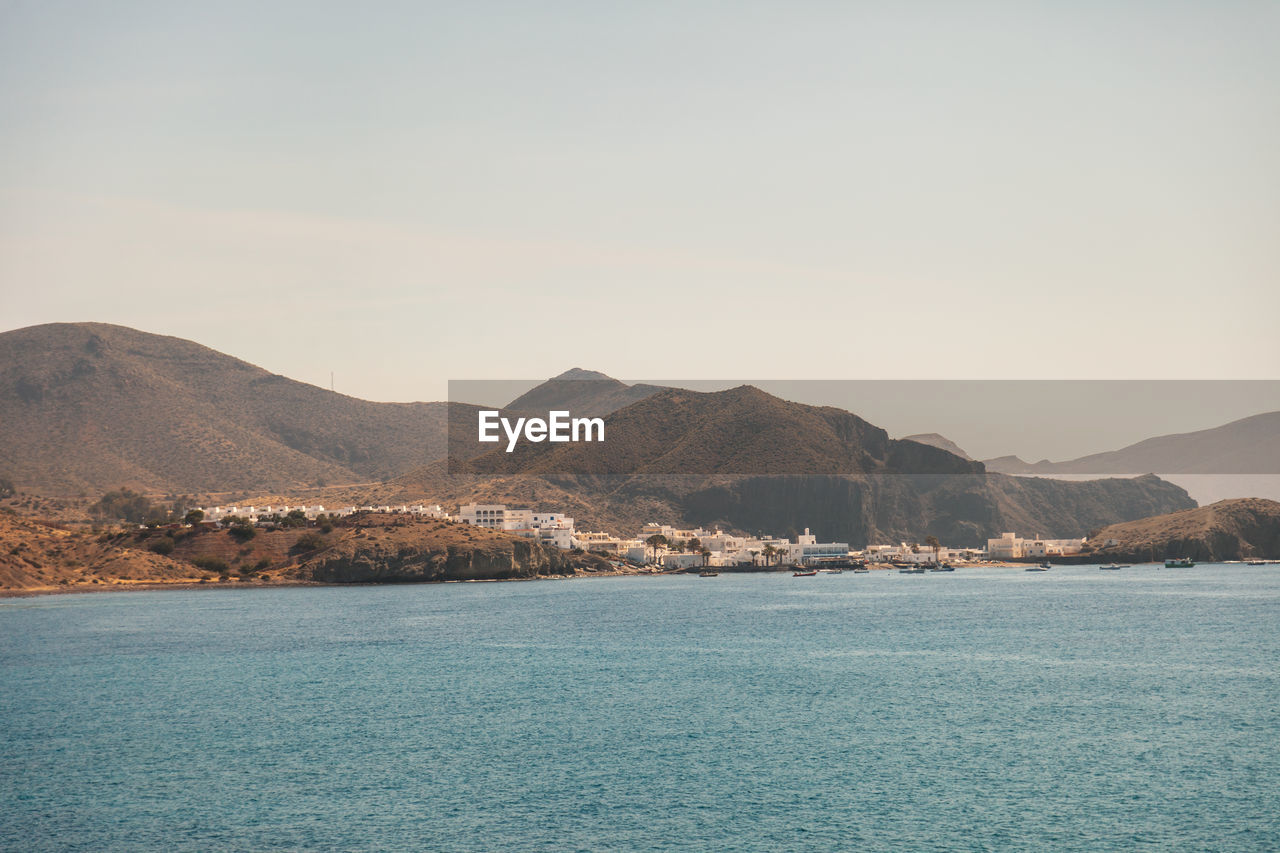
0, 323, 1194, 544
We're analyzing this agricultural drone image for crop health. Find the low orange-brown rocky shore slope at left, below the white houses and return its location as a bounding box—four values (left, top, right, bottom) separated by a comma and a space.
0, 514, 620, 593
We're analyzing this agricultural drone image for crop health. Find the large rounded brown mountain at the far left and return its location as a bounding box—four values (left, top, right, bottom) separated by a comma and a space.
0, 323, 474, 493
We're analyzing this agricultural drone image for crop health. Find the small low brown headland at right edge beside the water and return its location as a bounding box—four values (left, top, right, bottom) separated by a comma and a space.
1089, 498, 1280, 562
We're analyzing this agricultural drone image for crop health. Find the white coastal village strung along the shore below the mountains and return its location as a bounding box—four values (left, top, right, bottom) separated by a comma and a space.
200, 503, 1085, 570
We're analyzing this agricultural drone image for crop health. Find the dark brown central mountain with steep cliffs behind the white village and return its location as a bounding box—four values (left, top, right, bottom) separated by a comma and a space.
412, 386, 1194, 547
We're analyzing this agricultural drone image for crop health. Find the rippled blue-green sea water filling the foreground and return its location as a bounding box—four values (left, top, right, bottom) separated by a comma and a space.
0, 566, 1280, 850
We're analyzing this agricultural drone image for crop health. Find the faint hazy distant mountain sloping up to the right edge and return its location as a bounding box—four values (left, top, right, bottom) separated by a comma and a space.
987, 411, 1280, 475
